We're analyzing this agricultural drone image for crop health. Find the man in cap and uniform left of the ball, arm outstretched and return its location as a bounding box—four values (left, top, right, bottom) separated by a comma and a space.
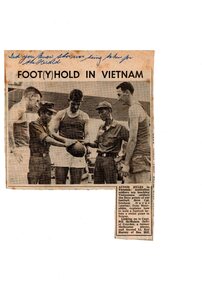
27, 102, 76, 184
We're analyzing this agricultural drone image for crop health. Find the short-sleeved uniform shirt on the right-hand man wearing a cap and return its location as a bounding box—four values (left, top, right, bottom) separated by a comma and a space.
95, 120, 129, 155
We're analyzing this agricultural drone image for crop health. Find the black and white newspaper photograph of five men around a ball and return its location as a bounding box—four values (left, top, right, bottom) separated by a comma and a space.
7, 81, 152, 186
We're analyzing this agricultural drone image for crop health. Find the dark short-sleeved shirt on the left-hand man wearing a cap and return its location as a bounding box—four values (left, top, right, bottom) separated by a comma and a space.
29, 118, 50, 153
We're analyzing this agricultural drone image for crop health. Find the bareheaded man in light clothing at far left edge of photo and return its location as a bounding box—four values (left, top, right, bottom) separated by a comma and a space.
7, 87, 42, 184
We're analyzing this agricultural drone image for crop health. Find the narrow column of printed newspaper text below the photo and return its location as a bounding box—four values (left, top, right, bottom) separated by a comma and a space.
116, 185, 152, 239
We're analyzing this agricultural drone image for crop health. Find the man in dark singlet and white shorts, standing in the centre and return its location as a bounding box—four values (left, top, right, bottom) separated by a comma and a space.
49, 89, 89, 184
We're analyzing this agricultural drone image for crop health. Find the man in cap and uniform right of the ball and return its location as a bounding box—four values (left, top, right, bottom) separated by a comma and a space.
86, 101, 129, 184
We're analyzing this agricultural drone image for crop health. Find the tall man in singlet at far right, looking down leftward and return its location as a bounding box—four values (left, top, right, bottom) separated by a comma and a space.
116, 82, 151, 183
